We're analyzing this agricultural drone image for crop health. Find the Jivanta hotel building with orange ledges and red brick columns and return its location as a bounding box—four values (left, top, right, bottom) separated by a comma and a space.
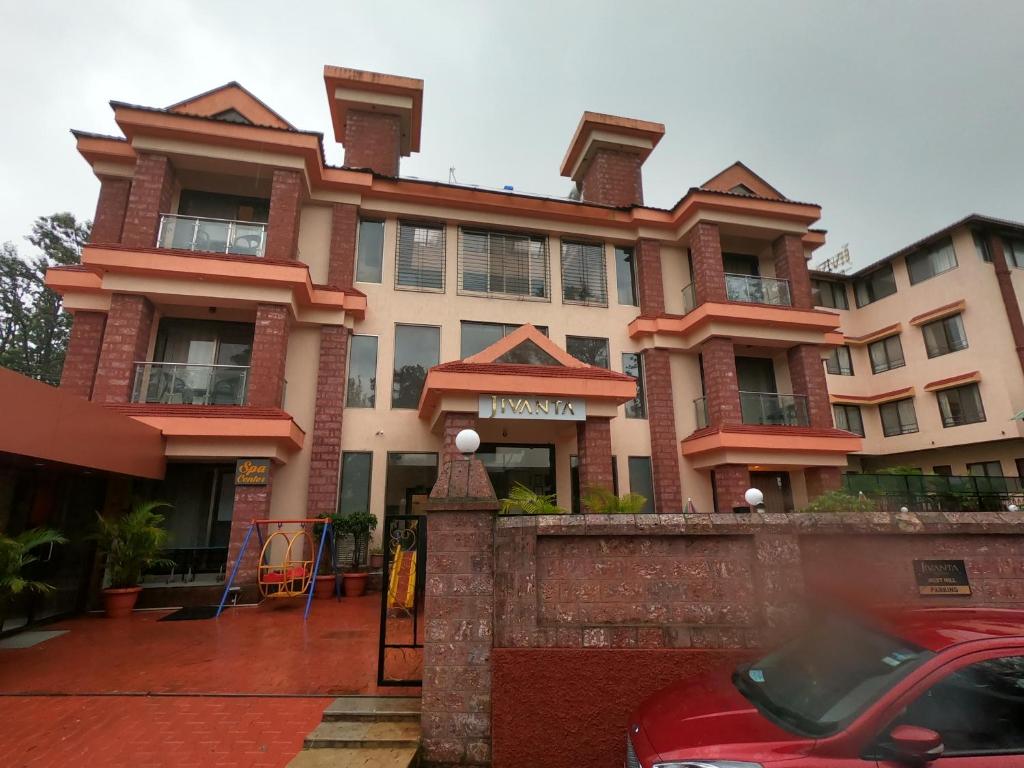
48, 67, 870, 589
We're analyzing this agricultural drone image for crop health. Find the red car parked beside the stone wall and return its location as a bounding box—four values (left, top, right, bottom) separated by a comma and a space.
626, 608, 1024, 768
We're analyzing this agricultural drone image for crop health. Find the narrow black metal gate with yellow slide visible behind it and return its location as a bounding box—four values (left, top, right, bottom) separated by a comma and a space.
377, 515, 427, 685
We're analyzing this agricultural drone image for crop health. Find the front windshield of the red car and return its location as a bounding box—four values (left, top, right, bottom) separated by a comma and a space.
732, 615, 934, 736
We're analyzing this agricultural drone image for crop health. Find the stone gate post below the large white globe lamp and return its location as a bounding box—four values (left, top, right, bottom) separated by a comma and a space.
421, 458, 498, 765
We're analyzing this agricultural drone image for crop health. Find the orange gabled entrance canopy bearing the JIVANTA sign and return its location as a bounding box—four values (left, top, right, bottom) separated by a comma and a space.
420, 324, 637, 428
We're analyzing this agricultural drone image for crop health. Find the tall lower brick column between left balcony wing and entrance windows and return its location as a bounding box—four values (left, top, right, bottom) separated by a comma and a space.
306, 326, 348, 517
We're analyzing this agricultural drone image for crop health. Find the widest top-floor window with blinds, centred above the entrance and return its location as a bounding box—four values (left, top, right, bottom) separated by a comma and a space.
459, 229, 551, 299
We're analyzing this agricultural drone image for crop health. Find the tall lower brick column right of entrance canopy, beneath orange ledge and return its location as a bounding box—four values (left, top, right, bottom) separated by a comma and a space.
643, 349, 683, 514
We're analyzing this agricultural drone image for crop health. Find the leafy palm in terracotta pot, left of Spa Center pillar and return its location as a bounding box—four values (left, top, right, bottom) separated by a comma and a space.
95, 502, 171, 618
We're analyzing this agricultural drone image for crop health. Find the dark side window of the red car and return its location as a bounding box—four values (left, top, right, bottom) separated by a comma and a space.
890, 656, 1024, 757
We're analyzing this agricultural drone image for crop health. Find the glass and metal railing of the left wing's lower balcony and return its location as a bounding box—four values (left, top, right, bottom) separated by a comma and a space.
131, 362, 249, 406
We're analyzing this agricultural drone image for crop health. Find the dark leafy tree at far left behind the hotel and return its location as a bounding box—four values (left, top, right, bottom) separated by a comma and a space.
0, 213, 91, 385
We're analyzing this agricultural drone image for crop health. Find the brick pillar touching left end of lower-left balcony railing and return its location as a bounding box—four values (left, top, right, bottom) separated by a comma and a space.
92, 293, 153, 402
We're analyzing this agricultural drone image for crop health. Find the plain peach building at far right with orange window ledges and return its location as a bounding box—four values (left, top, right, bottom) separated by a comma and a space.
812, 214, 1024, 477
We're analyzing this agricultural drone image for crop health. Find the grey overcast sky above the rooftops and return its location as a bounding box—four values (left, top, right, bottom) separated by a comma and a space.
0, 0, 1024, 265
